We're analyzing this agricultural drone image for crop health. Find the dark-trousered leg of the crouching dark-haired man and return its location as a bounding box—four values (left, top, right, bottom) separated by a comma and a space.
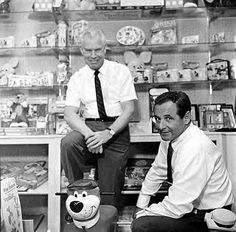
131, 216, 208, 232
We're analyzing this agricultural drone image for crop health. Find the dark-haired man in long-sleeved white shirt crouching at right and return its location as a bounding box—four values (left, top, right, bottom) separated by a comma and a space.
132, 92, 234, 232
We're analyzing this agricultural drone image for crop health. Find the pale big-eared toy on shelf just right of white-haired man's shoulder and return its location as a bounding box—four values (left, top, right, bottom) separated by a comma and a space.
124, 51, 152, 83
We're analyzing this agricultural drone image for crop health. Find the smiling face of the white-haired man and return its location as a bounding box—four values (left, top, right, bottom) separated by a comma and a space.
81, 38, 106, 70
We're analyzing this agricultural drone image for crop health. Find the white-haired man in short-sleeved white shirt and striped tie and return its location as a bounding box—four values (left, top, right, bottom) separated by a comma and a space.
61, 28, 137, 208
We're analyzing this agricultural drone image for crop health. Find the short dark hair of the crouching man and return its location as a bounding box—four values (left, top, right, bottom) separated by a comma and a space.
155, 91, 191, 118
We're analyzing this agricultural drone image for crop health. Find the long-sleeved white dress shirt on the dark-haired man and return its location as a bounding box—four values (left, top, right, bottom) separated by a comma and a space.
137, 123, 234, 218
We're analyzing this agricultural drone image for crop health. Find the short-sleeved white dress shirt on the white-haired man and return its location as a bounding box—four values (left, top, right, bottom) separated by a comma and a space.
66, 60, 137, 118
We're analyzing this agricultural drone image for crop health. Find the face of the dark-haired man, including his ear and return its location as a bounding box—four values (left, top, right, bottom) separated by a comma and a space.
154, 101, 190, 141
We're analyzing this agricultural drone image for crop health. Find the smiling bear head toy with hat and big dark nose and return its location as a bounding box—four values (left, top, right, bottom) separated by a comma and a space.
66, 179, 100, 231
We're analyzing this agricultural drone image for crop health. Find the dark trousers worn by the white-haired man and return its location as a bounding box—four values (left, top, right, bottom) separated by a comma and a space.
61, 121, 130, 208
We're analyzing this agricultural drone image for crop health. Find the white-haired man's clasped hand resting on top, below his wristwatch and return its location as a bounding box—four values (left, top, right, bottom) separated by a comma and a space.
86, 130, 112, 151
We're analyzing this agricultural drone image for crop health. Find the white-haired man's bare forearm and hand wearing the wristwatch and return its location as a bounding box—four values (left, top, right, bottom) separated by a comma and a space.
86, 100, 134, 149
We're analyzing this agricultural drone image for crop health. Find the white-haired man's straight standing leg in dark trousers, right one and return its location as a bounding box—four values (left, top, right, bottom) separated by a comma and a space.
98, 128, 130, 209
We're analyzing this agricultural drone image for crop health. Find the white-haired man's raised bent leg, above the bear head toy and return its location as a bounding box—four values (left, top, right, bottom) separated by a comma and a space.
61, 131, 94, 183
